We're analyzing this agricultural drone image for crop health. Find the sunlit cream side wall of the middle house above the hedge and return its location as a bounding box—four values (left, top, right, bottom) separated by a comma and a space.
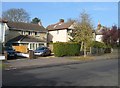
48, 29, 68, 42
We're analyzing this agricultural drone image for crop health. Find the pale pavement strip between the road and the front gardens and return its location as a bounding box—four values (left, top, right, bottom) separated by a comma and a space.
4, 49, 118, 70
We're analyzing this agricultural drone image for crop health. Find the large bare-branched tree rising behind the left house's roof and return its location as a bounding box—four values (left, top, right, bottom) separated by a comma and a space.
2, 8, 30, 22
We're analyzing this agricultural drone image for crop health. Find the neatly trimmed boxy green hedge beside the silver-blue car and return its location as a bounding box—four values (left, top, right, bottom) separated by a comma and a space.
53, 42, 80, 57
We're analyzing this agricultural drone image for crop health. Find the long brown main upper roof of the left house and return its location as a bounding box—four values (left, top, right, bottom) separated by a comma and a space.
7, 21, 47, 32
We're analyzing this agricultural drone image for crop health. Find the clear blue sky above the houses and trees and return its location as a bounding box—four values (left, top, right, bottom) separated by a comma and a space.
2, 2, 118, 27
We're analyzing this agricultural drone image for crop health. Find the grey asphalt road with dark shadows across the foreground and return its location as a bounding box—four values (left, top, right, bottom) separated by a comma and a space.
3, 59, 118, 86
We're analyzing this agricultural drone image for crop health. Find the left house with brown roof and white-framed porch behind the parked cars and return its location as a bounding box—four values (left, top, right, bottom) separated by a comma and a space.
0, 21, 47, 50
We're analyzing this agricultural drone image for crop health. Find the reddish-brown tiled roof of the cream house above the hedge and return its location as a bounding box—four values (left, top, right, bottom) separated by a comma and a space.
46, 22, 73, 30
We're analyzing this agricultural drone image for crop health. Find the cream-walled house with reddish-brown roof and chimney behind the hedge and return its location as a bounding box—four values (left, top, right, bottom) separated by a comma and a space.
46, 19, 74, 43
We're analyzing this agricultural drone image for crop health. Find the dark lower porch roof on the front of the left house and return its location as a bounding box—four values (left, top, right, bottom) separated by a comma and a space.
8, 35, 46, 43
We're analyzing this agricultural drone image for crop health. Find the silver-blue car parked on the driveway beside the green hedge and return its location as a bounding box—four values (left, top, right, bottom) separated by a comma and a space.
34, 47, 51, 56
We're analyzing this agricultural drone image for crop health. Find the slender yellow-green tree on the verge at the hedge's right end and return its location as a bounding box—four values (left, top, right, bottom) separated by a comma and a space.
72, 12, 93, 57
